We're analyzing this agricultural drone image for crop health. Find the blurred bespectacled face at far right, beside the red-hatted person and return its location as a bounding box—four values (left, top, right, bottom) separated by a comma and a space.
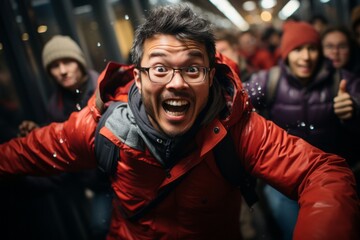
322, 32, 350, 68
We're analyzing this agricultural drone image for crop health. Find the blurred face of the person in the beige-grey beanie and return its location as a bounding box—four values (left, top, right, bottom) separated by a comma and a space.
50, 58, 86, 91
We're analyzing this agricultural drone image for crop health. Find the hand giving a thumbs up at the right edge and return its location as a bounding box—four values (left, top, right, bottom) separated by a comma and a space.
334, 79, 354, 120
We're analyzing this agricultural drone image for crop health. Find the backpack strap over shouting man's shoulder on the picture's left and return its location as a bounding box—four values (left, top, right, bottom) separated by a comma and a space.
95, 102, 122, 175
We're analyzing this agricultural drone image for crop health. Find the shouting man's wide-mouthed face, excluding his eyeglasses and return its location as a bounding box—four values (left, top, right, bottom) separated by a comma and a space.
134, 34, 215, 137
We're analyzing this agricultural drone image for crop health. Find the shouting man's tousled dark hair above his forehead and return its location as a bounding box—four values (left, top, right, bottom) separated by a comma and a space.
131, 4, 215, 67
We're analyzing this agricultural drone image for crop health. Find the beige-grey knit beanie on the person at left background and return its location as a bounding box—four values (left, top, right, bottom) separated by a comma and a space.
42, 35, 87, 71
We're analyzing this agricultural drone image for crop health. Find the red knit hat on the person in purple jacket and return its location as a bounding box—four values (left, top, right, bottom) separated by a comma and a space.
281, 21, 320, 60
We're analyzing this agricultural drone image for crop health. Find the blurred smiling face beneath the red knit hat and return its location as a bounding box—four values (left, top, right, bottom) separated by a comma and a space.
288, 44, 320, 83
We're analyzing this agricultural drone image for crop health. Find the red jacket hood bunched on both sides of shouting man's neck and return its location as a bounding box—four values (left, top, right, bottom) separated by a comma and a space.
99, 53, 253, 132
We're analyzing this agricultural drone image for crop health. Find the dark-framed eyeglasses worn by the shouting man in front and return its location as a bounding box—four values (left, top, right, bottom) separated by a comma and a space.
138, 65, 210, 84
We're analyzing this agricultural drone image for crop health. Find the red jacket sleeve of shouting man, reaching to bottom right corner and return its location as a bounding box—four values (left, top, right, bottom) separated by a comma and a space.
238, 113, 360, 240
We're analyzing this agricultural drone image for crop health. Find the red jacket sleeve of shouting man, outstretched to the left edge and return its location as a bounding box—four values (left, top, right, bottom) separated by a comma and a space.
0, 106, 97, 176
